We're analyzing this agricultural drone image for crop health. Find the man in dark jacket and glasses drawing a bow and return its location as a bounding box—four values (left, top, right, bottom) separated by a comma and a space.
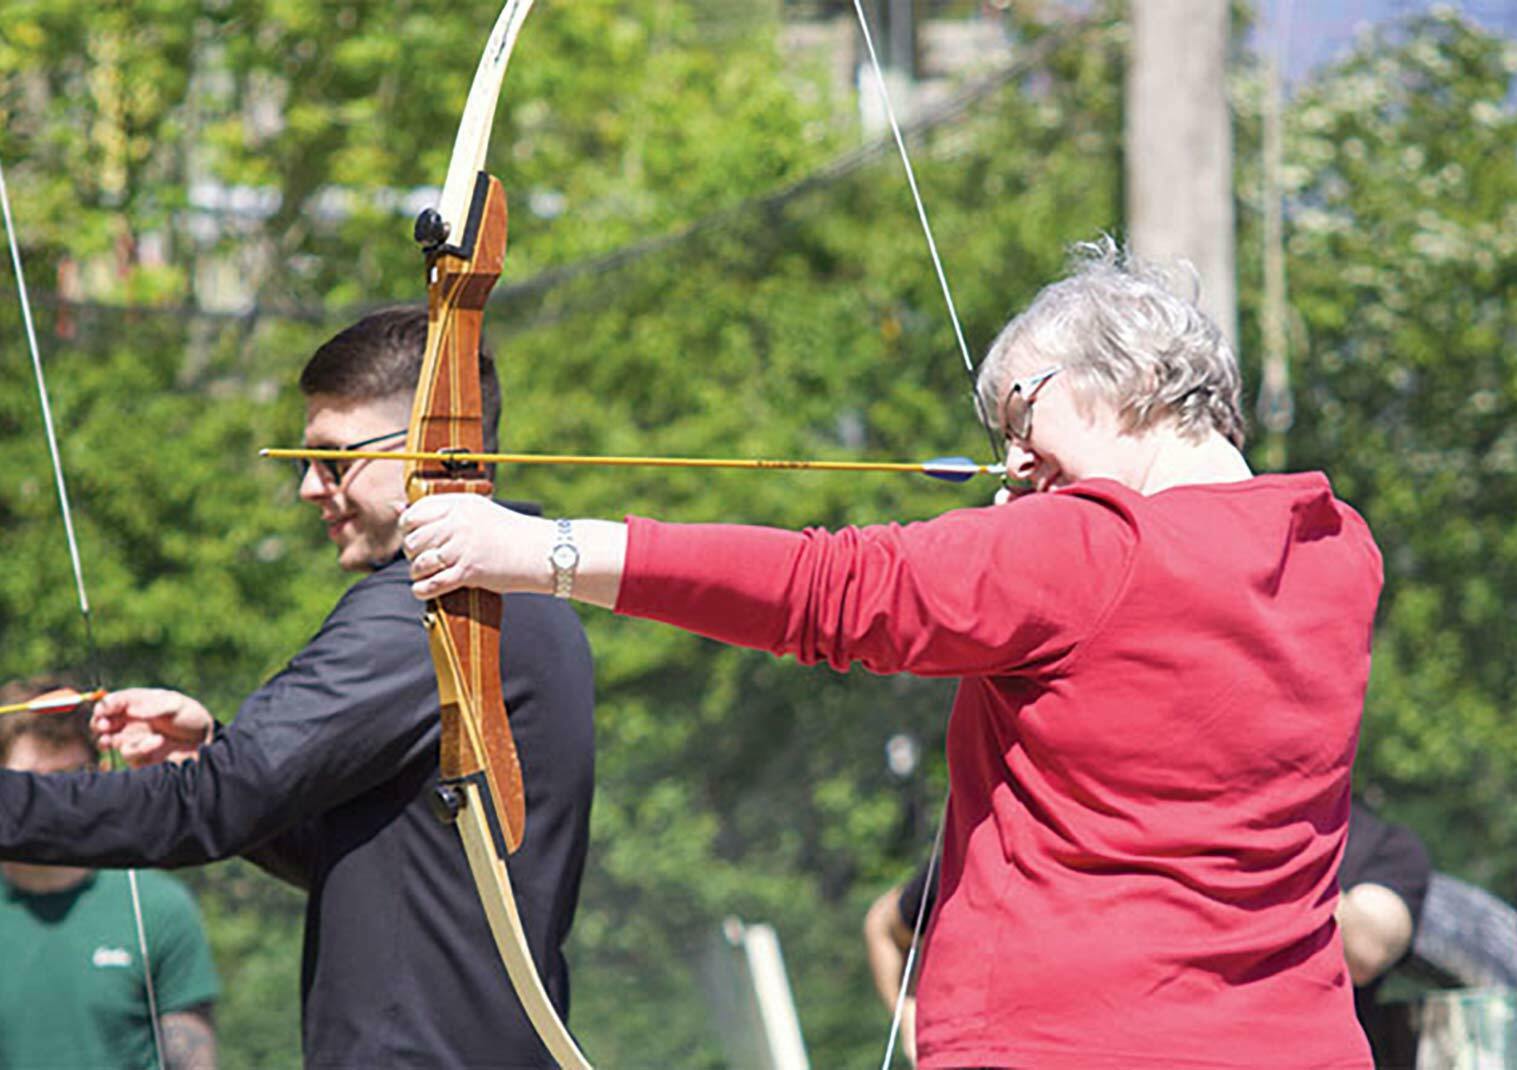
0, 310, 593, 1070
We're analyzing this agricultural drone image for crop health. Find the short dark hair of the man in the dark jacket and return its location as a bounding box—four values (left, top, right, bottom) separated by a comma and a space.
300, 305, 501, 452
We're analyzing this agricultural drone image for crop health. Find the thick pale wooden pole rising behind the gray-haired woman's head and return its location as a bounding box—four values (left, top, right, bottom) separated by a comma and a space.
1124, 0, 1238, 351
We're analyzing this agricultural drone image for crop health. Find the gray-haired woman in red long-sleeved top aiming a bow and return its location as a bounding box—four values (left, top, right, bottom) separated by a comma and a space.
402, 241, 1380, 1070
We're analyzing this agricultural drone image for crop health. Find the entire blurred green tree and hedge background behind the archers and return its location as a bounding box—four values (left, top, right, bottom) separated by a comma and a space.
0, 0, 1517, 1068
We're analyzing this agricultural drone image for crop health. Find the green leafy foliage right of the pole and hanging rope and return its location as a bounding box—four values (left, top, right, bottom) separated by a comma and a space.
1243, 12, 1517, 894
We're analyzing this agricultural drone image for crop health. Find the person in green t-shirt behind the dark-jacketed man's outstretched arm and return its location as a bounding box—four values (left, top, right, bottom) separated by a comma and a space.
0, 680, 218, 1070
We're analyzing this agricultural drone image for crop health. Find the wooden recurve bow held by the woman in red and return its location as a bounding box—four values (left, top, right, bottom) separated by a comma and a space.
405, 0, 590, 1070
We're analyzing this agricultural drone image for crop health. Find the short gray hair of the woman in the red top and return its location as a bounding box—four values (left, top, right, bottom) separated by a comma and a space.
977, 235, 1244, 448
